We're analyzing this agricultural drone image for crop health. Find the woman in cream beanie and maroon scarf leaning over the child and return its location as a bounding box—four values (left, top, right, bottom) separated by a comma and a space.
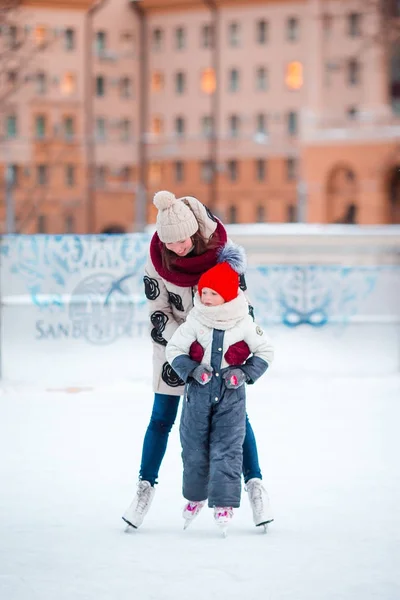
122, 191, 272, 528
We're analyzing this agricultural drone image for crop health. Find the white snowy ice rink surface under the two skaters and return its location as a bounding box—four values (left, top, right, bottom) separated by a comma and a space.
0, 350, 400, 600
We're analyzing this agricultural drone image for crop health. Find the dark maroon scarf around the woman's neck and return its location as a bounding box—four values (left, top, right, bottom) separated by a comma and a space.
150, 221, 228, 287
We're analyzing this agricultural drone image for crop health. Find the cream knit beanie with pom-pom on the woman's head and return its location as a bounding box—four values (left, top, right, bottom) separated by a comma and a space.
153, 191, 199, 244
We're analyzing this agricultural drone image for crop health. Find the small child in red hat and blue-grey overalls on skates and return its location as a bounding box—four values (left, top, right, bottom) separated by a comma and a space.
166, 244, 273, 529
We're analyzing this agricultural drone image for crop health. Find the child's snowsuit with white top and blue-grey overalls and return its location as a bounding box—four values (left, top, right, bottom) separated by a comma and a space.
167, 292, 273, 508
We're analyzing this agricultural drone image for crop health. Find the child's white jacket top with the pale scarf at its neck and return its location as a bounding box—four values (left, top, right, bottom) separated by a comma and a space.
166, 290, 274, 381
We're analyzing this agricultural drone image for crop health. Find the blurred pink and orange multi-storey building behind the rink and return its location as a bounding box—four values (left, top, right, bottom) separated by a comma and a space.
0, 0, 400, 233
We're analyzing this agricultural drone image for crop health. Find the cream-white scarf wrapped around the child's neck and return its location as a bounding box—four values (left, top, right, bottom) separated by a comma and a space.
188, 290, 249, 331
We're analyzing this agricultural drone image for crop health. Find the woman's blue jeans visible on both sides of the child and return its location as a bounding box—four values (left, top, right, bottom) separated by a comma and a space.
139, 394, 262, 485
